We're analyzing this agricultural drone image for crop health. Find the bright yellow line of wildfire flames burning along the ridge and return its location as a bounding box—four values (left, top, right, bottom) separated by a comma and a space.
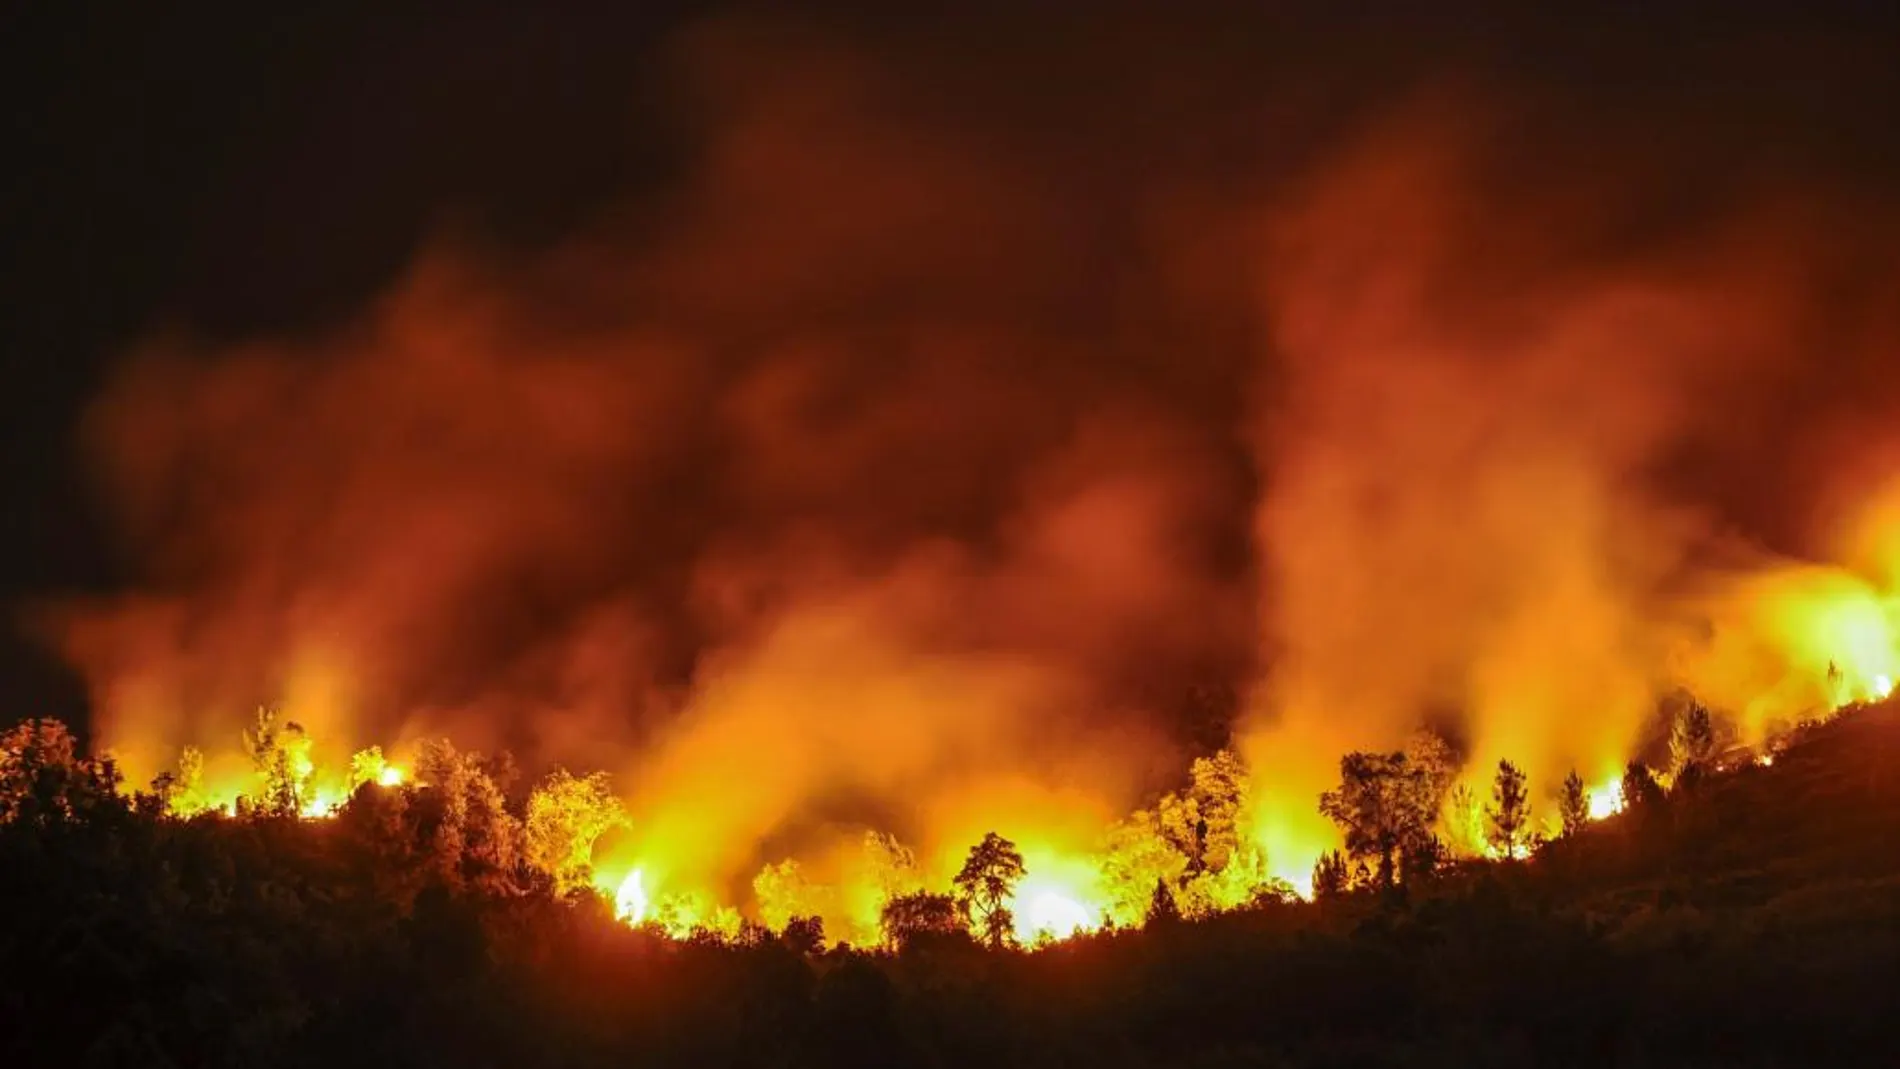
89, 480, 1900, 946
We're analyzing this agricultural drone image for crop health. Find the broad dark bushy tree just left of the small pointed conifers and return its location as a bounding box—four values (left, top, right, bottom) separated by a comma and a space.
1319, 754, 1442, 889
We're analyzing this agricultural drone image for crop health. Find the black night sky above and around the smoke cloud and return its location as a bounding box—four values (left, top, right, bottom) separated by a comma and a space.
0, 2, 1900, 736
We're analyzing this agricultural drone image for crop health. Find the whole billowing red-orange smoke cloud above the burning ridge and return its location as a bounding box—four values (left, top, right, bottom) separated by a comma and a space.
37, 10, 1900, 885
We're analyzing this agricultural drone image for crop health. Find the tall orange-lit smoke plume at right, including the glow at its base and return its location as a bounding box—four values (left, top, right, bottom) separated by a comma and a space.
1246, 101, 1900, 875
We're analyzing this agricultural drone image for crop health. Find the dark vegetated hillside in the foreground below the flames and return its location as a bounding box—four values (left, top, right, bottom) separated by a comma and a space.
0, 704, 1900, 1069
